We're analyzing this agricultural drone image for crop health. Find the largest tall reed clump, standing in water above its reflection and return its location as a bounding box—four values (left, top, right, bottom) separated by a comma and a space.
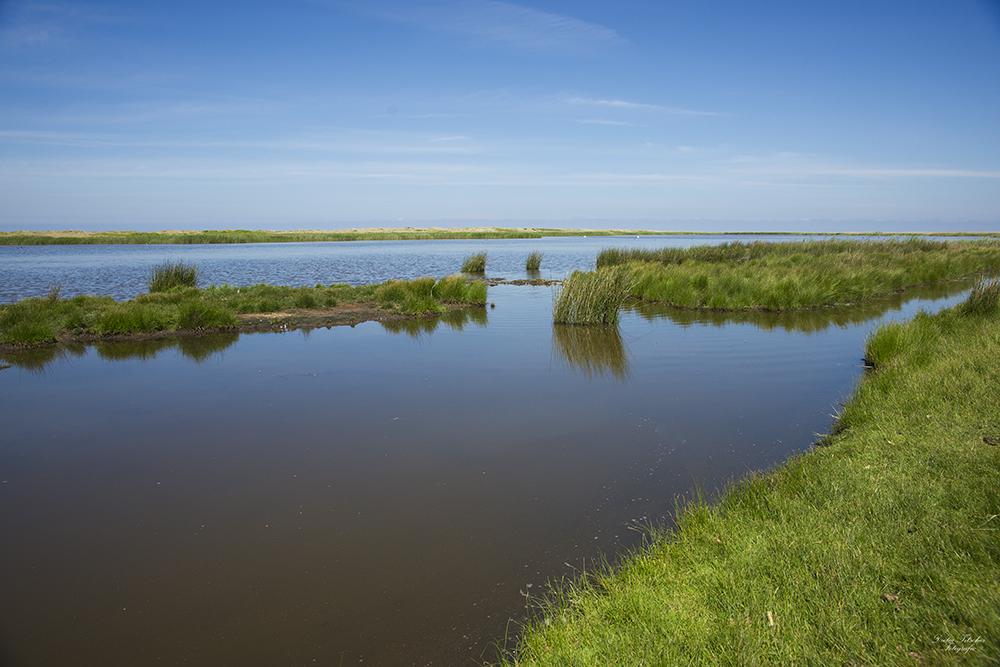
552, 267, 633, 325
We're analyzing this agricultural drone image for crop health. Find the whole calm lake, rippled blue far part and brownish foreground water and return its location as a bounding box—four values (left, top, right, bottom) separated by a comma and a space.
0, 237, 968, 667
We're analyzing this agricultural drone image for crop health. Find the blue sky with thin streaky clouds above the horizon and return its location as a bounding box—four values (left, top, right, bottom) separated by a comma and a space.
0, 0, 1000, 231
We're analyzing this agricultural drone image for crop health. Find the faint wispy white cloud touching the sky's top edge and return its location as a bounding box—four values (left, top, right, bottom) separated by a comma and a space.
361, 0, 624, 51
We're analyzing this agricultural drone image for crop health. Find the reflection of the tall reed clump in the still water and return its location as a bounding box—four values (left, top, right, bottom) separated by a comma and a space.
552, 324, 629, 382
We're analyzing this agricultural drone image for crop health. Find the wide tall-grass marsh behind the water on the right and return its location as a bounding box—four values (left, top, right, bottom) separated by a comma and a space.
597, 238, 1000, 310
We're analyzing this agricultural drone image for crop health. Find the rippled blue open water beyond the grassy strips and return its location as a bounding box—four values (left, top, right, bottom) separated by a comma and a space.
0, 235, 844, 303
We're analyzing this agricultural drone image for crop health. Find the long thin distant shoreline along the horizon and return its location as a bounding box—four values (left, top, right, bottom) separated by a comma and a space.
0, 227, 1000, 245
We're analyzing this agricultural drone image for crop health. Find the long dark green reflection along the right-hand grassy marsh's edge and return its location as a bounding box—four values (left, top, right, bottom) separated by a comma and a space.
623, 280, 975, 333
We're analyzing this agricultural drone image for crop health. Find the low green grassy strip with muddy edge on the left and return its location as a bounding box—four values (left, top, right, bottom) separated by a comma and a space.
0, 274, 487, 347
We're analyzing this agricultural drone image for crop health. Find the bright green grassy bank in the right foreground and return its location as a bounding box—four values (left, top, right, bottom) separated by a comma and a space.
505, 282, 1000, 667
